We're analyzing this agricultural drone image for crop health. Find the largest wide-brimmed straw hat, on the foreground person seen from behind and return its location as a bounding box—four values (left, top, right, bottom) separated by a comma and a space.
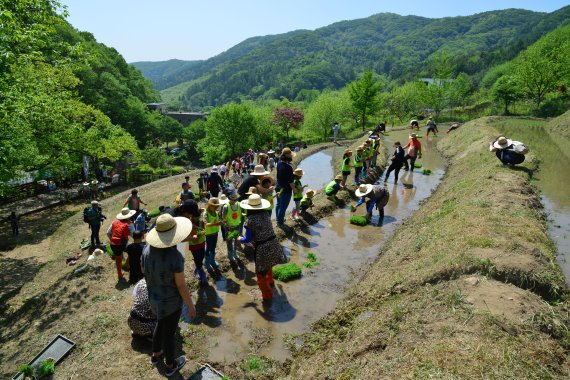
146, 214, 192, 248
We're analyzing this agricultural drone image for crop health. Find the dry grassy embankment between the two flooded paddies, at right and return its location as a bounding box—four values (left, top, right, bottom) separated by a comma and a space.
288, 119, 570, 379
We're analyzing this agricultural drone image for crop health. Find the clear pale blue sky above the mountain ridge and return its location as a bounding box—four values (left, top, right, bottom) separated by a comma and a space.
61, 0, 569, 62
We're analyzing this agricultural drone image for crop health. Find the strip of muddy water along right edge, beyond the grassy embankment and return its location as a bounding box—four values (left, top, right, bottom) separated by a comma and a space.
492, 121, 570, 285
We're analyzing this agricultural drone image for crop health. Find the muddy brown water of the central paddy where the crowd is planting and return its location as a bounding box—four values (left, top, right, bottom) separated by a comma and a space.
196, 131, 444, 362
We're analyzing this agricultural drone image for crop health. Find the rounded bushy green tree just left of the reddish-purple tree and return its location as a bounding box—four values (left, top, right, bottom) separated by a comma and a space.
198, 103, 256, 165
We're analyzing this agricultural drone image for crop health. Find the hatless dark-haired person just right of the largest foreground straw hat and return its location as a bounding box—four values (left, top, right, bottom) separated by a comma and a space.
180, 199, 208, 285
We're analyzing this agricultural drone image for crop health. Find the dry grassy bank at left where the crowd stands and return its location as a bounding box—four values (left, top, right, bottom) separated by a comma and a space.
0, 138, 374, 378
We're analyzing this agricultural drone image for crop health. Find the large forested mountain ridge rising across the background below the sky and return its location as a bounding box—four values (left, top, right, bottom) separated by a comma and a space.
135, 7, 570, 109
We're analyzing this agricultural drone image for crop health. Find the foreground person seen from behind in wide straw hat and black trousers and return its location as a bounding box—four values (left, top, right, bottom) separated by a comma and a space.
141, 214, 196, 376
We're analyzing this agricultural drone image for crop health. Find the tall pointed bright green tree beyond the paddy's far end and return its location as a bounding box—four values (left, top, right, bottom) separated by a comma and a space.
348, 70, 382, 131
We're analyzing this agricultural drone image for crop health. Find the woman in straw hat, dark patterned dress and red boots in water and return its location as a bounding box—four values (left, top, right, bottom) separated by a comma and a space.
239, 194, 287, 303
